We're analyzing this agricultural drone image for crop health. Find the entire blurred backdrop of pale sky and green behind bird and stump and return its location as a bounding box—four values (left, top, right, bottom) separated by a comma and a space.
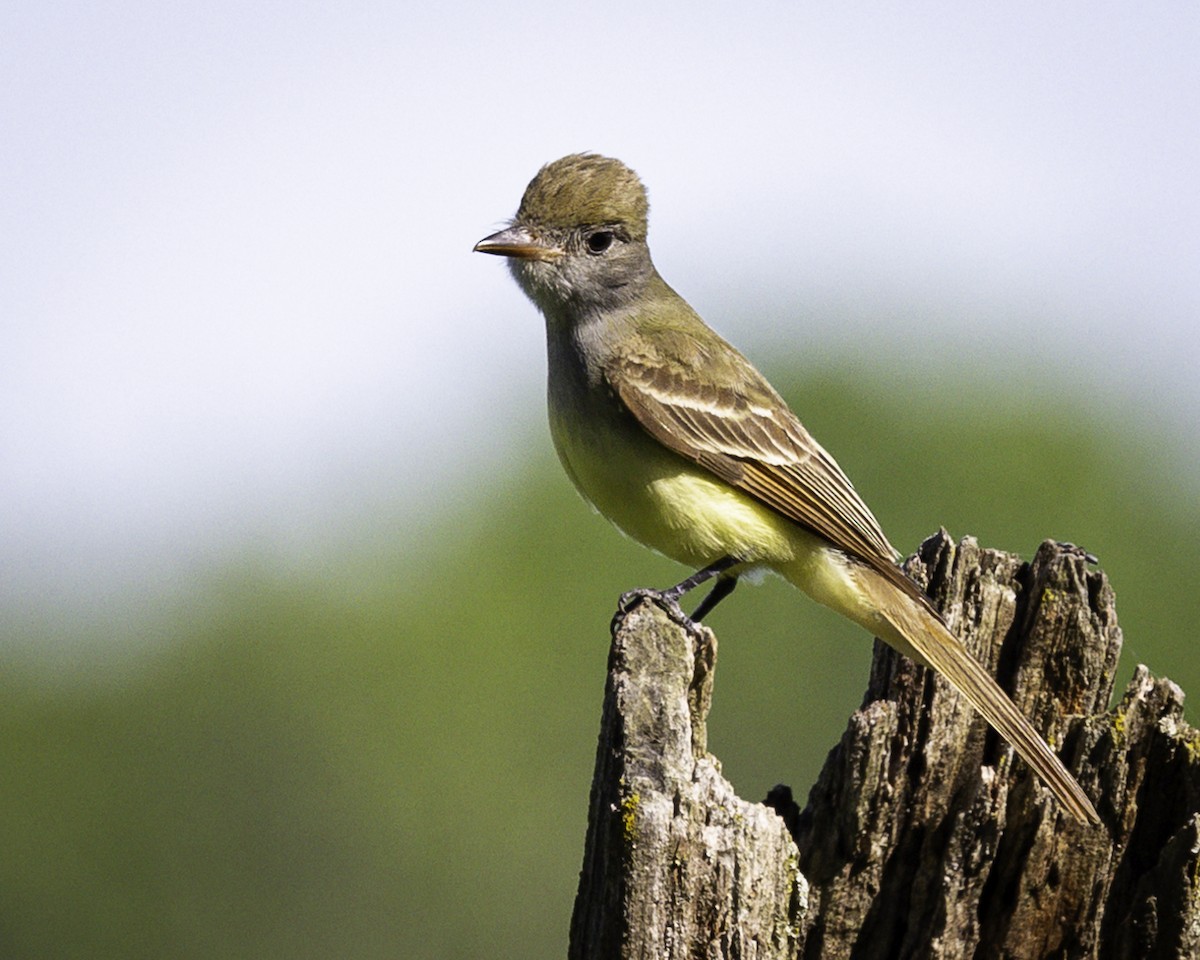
0, 0, 1200, 958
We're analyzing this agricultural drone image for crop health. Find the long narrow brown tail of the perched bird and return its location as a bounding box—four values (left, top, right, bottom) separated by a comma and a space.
860, 571, 1100, 823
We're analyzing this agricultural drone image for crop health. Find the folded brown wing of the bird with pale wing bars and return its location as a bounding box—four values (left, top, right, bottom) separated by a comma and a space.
606, 347, 920, 596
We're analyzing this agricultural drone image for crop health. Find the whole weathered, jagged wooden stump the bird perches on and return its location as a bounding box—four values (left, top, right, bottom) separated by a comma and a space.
570, 532, 1200, 960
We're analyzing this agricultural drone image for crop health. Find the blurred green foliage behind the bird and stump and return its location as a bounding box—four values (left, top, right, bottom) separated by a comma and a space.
0, 367, 1200, 960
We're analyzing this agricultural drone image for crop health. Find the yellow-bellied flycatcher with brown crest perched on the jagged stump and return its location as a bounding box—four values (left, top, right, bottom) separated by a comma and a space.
475, 154, 1099, 823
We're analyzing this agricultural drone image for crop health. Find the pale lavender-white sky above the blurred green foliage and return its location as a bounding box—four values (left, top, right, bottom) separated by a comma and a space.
0, 0, 1200, 633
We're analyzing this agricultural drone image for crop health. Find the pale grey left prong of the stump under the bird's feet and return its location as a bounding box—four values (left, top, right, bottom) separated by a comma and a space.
570, 602, 808, 960
